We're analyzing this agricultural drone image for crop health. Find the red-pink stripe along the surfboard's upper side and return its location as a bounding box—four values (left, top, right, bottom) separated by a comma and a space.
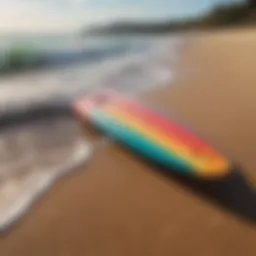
106, 96, 216, 153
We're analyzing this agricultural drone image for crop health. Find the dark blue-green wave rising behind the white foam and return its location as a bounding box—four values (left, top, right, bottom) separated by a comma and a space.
0, 38, 146, 75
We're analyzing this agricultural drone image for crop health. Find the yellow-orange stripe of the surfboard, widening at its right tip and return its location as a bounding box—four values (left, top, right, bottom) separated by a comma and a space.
106, 106, 229, 174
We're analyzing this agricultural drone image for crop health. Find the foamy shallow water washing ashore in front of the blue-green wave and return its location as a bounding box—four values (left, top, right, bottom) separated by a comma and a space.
0, 34, 179, 231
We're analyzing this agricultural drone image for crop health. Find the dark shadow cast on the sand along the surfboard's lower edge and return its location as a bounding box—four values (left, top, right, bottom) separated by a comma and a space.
119, 145, 256, 224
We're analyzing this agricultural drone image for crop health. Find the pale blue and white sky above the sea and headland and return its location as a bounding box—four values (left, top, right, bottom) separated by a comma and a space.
0, 0, 242, 33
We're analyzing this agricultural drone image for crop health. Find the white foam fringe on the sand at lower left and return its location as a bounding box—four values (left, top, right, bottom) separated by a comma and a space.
0, 141, 91, 231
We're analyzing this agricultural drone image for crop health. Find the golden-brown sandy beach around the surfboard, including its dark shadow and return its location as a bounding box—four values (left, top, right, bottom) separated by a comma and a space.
0, 30, 256, 256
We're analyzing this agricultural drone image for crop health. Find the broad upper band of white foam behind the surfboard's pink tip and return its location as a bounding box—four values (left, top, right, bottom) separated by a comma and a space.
0, 35, 179, 109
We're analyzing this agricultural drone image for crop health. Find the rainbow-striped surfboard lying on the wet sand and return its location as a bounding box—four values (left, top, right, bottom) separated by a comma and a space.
73, 92, 231, 179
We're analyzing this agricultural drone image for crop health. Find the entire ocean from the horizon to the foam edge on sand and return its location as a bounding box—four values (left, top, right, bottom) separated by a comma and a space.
0, 33, 185, 232
